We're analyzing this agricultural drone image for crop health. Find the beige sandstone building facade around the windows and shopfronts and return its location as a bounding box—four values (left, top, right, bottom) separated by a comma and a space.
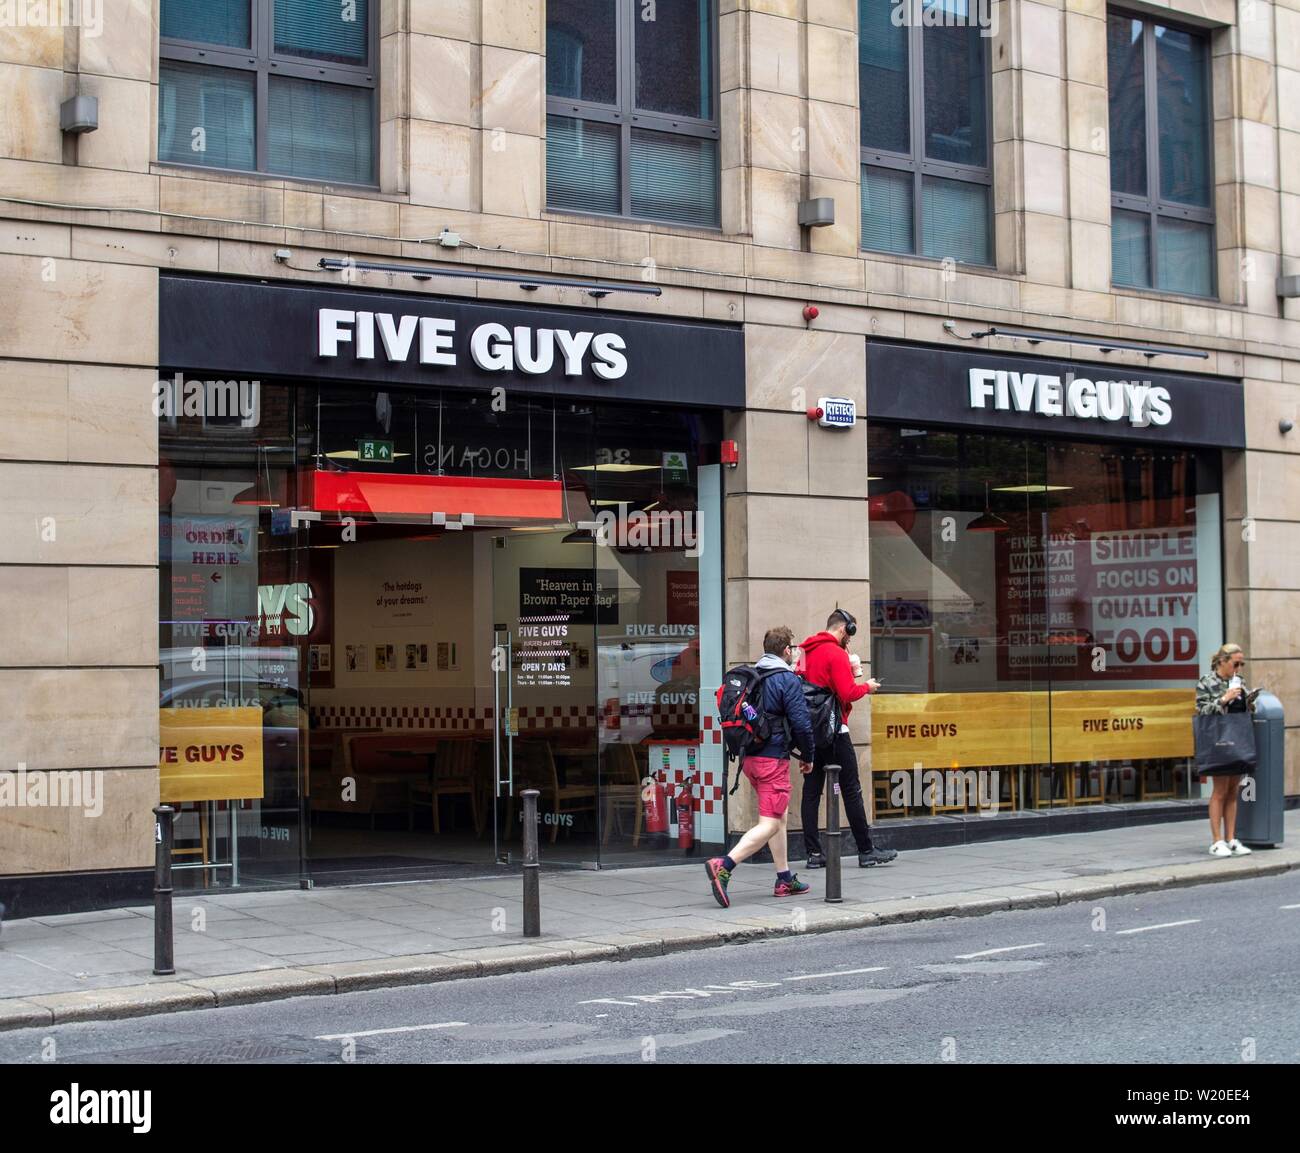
0, 0, 1300, 898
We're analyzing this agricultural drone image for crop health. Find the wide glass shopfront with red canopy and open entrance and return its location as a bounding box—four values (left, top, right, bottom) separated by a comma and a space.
160, 377, 724, 885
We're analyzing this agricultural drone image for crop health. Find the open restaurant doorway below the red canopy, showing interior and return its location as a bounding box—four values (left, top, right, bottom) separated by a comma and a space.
299, 513, 603, 883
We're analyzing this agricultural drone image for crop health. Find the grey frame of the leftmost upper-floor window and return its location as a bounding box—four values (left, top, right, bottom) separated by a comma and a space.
157, 0, 381, 188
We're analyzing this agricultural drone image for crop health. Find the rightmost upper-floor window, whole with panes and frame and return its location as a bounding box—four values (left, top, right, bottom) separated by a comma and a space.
1106, 12, 1214, 296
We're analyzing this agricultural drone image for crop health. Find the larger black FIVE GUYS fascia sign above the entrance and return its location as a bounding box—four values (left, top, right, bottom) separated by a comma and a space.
159, 276, 745, 408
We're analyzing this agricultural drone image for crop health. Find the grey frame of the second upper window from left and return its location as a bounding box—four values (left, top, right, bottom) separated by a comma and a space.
546, 0, 723, 231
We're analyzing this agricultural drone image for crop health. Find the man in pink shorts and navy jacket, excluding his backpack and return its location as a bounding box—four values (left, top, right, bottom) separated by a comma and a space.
705, 627, 814, 909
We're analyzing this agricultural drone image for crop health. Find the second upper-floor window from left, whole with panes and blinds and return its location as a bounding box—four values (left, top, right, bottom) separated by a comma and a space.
546, 0, 719, 227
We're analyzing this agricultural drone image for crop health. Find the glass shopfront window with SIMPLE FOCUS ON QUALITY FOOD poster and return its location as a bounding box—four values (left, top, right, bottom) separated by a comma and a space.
868, 422, 1222, 818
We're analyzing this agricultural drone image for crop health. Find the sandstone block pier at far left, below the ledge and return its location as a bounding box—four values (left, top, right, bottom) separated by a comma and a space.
0, 266, 159, 874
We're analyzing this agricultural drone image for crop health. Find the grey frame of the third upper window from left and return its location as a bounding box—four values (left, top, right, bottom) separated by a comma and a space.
858, 0, 997, 268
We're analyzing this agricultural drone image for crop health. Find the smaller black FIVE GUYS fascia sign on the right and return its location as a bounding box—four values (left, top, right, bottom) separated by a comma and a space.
867, 341, 1245, 448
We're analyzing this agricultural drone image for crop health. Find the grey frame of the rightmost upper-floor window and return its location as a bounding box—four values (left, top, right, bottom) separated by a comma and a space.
1106, 6, 1218, 300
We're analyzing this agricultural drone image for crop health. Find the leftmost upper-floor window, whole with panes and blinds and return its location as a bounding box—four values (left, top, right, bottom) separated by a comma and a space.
159, 0, 377, 185
